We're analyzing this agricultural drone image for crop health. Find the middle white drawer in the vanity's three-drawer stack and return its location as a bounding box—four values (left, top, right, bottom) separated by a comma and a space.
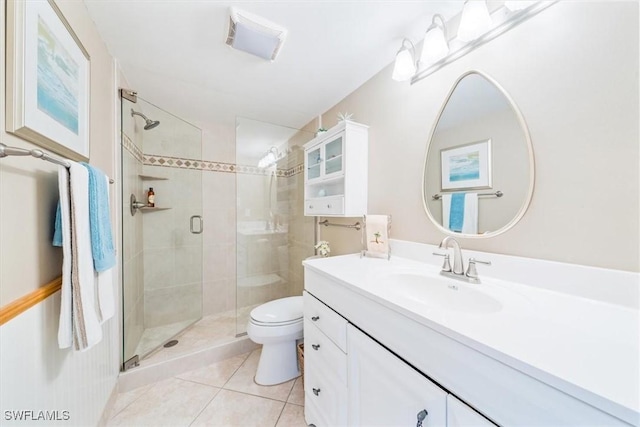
304, 319, 347, 386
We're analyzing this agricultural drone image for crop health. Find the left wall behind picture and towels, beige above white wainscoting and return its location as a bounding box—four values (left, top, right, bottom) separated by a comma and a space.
0, 0, 120, 426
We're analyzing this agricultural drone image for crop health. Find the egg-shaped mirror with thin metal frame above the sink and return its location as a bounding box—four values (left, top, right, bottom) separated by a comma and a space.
422, 71, 534, 237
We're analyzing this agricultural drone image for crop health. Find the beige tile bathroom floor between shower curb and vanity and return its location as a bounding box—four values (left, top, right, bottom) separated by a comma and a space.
108, 349, 306, 427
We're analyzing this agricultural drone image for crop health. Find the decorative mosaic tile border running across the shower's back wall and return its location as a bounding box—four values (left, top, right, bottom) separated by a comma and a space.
142, 153, 304, 178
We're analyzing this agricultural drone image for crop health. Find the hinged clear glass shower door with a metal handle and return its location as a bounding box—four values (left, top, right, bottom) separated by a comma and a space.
121, 91, 203, 369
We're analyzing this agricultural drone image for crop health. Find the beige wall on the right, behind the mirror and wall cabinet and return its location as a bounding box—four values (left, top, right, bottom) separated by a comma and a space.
322, 1, 640, 271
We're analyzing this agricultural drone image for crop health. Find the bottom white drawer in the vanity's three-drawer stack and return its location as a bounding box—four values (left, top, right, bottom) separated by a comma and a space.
304, 360, 347, 427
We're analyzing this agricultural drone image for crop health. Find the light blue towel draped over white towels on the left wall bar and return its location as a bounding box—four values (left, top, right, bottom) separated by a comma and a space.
82, 163, 116, 273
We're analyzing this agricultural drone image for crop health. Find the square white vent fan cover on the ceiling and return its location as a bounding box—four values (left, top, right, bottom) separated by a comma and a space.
227, 7, 287, 61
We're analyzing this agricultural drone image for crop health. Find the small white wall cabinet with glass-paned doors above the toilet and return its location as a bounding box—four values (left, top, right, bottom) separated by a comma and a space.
304, 121, 369, 216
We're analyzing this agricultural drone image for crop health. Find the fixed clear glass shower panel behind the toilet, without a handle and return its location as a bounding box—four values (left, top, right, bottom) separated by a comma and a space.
236, 118, 314, 335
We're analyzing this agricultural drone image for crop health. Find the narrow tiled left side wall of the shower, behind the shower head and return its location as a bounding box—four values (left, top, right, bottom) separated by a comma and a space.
122, 103, 144, 360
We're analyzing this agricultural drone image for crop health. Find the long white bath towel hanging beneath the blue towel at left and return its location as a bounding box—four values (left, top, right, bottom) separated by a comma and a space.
58, 162, 102, 351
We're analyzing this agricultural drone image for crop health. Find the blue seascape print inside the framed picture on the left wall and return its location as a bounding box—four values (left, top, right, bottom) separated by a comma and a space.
38, 17, 79, 135
